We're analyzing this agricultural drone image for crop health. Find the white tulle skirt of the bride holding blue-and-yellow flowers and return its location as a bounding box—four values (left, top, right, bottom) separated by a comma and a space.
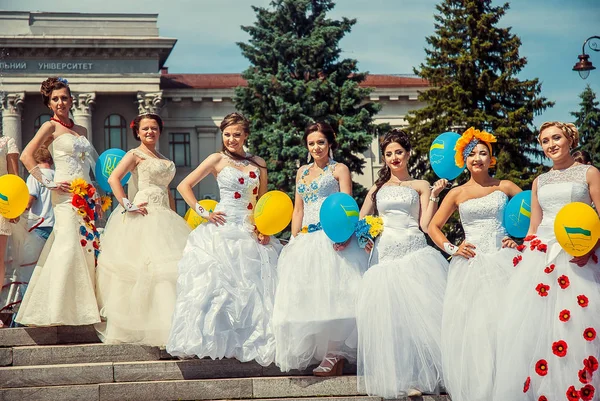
356, 246, 448, 398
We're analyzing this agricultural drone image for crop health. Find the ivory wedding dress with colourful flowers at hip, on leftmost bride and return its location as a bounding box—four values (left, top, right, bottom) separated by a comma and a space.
15, 133, 100, 326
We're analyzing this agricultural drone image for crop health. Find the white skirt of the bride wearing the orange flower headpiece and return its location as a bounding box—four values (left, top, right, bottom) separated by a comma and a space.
442, 249, 518, 401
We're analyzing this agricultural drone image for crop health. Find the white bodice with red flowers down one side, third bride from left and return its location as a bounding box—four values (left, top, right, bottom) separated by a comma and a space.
215, 166, 260, 231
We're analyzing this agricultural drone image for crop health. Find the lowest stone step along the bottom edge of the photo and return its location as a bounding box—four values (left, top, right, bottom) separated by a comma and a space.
0, 376, 449, 401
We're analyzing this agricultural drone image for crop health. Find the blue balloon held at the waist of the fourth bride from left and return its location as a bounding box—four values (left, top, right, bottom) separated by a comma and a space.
319, 192, 360, 243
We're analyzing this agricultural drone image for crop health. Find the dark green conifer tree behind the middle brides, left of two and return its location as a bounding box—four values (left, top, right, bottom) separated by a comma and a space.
235, 0, 379, 204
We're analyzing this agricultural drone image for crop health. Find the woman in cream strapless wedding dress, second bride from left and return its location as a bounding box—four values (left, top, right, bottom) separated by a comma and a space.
96, 114, 190, 346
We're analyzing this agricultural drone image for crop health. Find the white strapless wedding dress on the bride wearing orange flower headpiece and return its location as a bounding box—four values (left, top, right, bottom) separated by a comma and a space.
442, 190, 518, 401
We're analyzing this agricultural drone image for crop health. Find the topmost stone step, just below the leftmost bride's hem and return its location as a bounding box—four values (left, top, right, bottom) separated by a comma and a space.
0, 326, 100, 347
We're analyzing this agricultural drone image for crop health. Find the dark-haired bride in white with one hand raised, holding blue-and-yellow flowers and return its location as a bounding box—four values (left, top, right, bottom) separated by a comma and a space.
356, 130, 448, 398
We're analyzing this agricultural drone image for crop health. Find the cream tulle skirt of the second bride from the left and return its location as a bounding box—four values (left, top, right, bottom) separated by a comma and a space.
95, 204, 190, 346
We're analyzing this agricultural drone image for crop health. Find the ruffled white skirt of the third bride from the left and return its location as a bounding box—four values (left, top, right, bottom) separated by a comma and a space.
167, 223, 281, 366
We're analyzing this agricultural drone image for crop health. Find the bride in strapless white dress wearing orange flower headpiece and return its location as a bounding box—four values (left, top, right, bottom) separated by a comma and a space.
429, 128, 521, 401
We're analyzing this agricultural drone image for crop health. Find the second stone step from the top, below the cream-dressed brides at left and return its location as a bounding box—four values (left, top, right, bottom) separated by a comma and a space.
9, 343, 173, 366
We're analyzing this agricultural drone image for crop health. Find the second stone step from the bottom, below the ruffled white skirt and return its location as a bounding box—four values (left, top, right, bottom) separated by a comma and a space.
0, 356, 356, 387
